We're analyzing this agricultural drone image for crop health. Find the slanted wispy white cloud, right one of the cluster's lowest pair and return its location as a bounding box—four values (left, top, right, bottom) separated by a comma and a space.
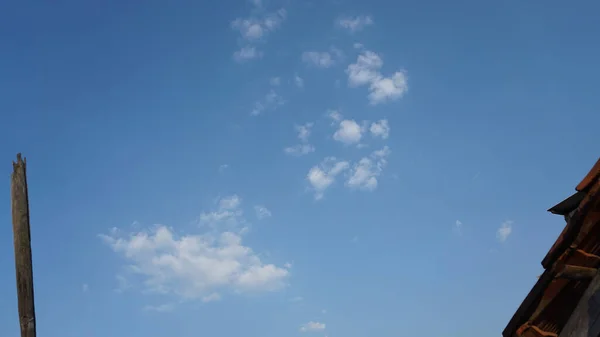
346, 146, 390, 191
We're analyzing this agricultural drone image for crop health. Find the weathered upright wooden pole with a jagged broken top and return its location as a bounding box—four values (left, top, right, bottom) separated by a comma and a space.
10, 153, 35, 337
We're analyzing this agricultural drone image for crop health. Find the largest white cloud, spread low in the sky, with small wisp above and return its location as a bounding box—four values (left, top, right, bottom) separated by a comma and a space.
100, 209, 289, 302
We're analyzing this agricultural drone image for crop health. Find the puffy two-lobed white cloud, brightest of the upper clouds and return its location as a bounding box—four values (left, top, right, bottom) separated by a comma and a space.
346, 50, 408, 105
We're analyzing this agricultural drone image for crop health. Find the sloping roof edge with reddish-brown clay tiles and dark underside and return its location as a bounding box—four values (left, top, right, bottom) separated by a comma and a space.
502, 159, 600, 337
